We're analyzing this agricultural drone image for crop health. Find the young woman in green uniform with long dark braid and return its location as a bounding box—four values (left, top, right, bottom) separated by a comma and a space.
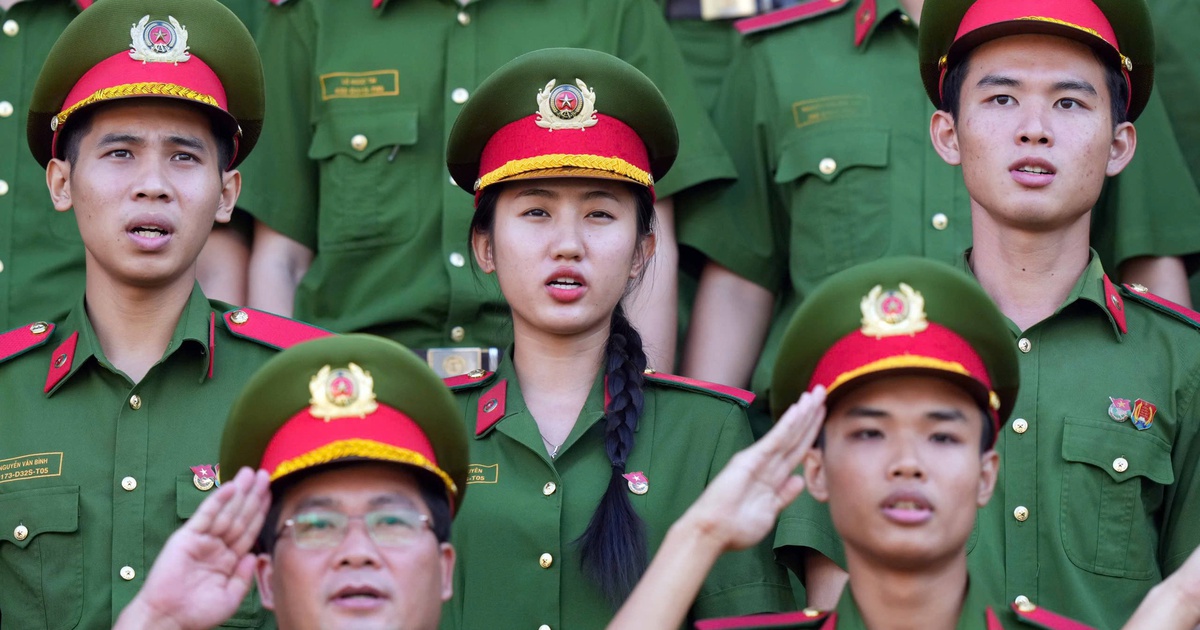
442, 48, 791, 629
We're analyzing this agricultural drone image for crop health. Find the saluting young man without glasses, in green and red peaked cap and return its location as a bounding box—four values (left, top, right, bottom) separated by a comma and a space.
613, 258, 1099, 630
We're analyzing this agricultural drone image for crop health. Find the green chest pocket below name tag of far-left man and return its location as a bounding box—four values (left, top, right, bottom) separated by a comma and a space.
0, 486, 83, 630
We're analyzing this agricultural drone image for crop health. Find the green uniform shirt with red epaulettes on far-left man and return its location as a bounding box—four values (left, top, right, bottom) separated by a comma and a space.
0, 287, 323, 630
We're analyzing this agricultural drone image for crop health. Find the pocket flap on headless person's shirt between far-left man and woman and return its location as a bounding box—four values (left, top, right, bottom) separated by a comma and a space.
308, 106, 416, 162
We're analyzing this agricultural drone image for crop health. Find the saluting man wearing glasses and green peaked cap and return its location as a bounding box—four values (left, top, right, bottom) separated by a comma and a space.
116, 335, 467, 630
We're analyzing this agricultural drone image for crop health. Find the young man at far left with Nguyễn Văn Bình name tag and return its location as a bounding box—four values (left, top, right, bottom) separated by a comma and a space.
0, 0, 326, 629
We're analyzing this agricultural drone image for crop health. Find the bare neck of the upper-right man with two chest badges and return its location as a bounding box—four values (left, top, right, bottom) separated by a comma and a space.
971, 200, 1091, 330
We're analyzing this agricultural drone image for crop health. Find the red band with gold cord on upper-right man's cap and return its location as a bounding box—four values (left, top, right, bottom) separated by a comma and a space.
938, 0, 1133, 112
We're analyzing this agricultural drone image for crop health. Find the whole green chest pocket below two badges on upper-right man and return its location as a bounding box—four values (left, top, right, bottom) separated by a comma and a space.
1060, 418, 1175, 580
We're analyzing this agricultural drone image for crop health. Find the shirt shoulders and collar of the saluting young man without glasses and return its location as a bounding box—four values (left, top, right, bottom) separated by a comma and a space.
696, 584, 1084, 630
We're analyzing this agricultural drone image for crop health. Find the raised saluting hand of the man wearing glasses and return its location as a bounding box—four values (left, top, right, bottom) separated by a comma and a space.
114, 468, 271, 630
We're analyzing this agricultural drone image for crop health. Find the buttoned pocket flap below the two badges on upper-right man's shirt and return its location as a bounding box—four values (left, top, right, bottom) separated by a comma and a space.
1062, 418, 1175, 486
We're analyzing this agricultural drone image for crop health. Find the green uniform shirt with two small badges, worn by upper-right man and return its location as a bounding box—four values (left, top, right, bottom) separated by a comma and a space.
775, 252, 1200, 628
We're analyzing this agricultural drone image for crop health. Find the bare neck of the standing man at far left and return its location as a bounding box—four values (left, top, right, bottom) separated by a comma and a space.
84, 274, 193, 383
